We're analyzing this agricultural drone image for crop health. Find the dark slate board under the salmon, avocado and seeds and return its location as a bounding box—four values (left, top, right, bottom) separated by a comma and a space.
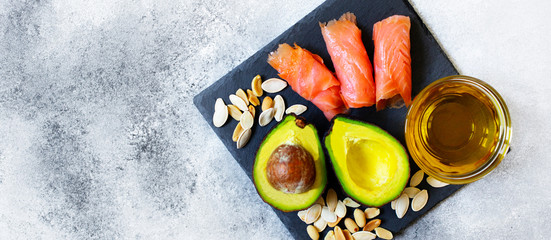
193, 0, 461, 239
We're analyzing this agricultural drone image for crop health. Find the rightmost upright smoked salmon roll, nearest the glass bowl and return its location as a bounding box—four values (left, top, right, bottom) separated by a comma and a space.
373, 15, 411, 110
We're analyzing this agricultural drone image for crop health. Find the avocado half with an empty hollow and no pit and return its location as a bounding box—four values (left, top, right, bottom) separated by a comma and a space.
325, 116, 409, 207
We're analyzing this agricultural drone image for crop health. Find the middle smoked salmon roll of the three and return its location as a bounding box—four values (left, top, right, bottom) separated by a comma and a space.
320, 12, 375, 108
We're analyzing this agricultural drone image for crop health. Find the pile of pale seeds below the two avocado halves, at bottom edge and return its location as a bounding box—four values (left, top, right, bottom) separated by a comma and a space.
298, 189, 393, 240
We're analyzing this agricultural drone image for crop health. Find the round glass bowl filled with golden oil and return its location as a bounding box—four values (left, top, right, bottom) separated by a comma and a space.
405, 76, 511, 184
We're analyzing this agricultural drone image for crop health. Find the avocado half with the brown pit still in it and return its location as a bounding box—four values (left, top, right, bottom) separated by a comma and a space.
253, 114, 327, 212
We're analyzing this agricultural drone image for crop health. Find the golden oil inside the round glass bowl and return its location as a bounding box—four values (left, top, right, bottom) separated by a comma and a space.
408, 83, 500, 175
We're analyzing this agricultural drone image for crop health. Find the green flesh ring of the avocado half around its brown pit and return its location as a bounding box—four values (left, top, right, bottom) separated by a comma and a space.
253, 115, 327, 212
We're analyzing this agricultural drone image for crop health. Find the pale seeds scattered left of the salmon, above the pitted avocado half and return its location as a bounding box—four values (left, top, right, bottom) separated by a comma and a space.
212, 75, 307, 149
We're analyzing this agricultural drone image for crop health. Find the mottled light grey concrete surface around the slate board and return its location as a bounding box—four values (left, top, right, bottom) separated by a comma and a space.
0, 0, 551, 239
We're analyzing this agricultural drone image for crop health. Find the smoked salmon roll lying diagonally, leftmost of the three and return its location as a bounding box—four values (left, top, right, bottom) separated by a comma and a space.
268, 43, 348, 120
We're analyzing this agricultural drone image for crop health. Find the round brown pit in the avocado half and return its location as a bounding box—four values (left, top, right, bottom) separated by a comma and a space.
266, 144, 316, 193
